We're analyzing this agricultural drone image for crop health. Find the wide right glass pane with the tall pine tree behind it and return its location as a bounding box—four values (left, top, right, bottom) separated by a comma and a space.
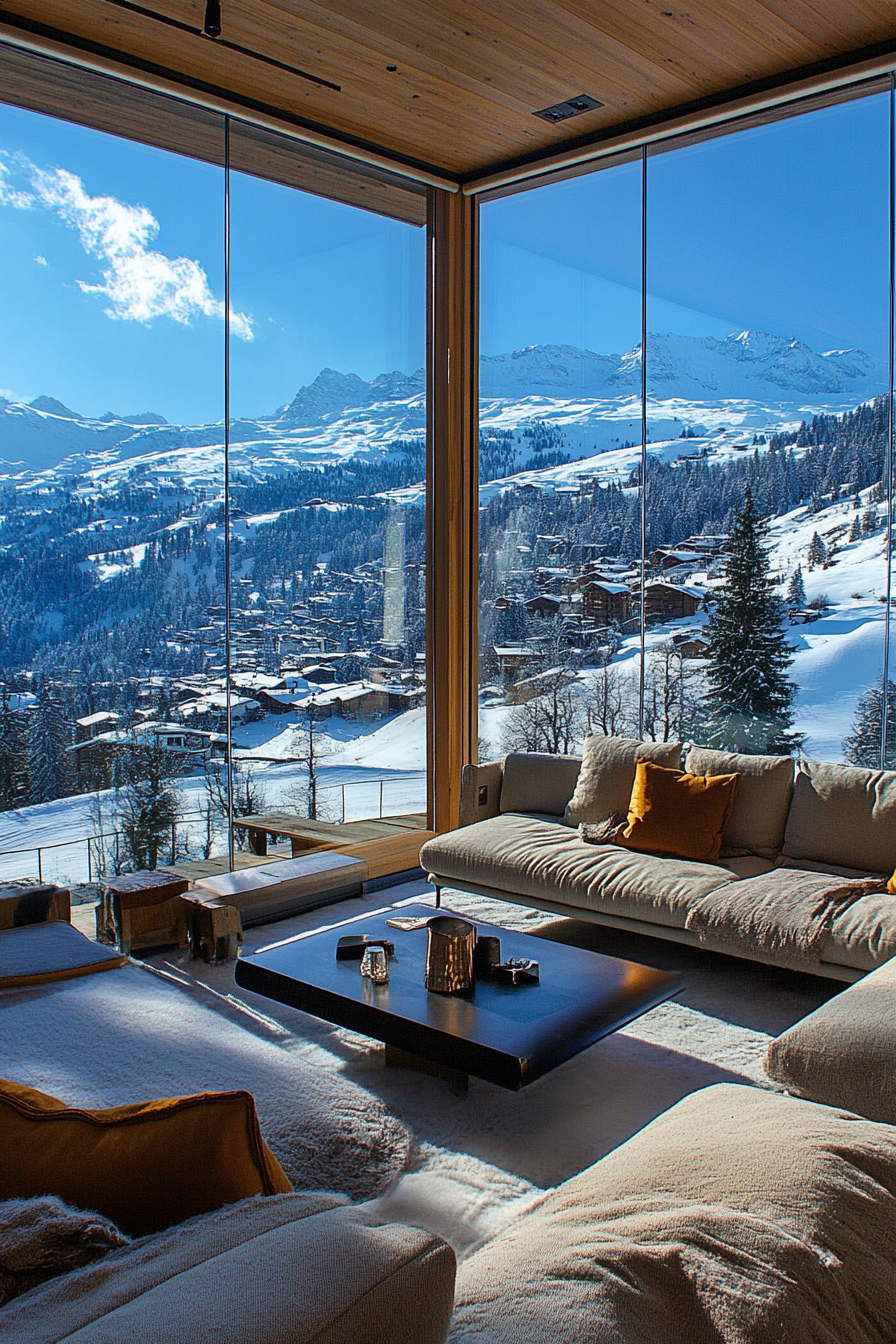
646, 94, 889, 765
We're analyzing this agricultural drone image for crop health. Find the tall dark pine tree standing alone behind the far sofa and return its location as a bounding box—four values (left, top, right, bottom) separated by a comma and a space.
705, 485, 801, 754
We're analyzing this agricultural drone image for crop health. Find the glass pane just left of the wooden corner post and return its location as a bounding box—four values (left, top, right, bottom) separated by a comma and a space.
231, 129, 426, 868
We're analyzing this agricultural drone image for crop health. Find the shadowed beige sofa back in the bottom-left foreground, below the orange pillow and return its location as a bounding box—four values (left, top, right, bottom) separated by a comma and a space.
0, 1193, 454, 1344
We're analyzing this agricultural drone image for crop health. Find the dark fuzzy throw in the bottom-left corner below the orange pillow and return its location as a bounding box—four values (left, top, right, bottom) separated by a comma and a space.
0, 1195, 130, 1306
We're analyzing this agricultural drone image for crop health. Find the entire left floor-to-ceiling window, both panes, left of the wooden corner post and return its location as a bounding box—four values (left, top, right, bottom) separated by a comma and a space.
0, 44, 426, 883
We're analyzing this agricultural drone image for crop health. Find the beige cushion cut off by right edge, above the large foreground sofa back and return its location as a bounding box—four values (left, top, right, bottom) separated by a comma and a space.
766, 961, 896, 1125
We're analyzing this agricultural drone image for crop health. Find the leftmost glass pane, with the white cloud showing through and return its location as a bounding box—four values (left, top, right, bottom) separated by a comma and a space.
0, 97, 226, 883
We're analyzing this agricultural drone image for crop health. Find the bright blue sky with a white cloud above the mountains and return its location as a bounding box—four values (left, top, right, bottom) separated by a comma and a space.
0, 95, 888, 423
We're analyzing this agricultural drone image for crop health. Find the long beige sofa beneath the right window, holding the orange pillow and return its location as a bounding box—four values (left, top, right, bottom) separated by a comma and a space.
420, 738, 896, 981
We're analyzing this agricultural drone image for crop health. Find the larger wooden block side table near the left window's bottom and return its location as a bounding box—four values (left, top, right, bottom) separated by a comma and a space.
97, 870, 189, 953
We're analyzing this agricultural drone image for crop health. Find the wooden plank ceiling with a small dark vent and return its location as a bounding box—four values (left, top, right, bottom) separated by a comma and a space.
0, 0, 896, 180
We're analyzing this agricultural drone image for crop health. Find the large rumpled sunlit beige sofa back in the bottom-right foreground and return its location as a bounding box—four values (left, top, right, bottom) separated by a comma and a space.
450, 1085, 896, 1344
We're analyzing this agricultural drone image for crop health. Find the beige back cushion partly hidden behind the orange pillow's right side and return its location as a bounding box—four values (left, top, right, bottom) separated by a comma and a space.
685, 746, 794, 859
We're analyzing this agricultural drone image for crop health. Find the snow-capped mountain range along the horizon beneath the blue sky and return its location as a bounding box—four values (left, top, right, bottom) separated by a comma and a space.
0, 331, 888, 472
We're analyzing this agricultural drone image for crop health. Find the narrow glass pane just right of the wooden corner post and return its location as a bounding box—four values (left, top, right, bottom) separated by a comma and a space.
480, 163, 641, 759
